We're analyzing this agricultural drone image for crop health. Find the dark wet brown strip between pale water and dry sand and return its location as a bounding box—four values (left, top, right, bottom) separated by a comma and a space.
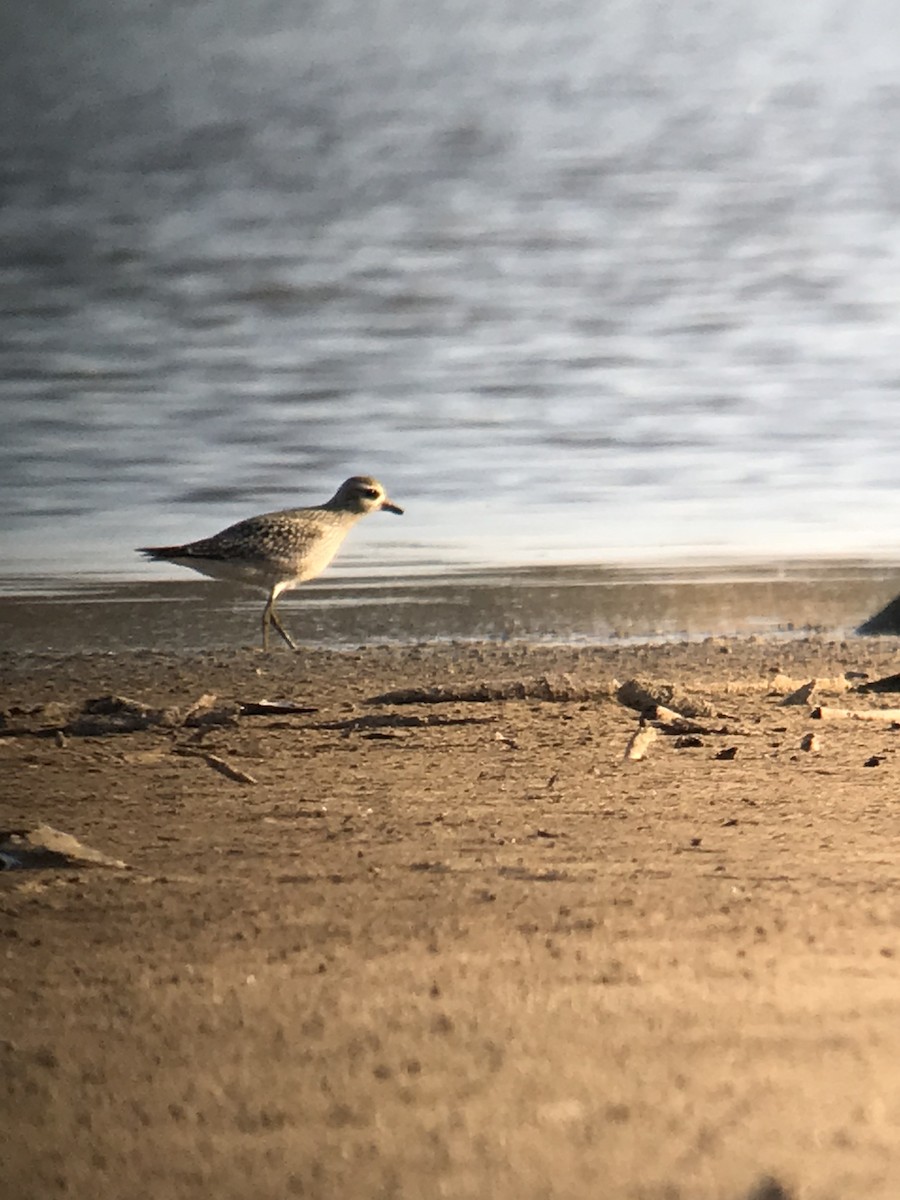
0, 559, 900, 653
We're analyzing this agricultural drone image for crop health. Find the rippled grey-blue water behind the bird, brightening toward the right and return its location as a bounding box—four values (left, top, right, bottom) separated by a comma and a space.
0, 0, 900, 590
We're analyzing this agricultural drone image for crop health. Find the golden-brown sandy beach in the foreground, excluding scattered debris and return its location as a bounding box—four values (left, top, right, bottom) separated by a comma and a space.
0, 637, 900, 1200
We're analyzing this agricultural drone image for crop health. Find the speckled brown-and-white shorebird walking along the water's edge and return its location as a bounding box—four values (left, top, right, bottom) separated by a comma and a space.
138, 475, 403, 650
